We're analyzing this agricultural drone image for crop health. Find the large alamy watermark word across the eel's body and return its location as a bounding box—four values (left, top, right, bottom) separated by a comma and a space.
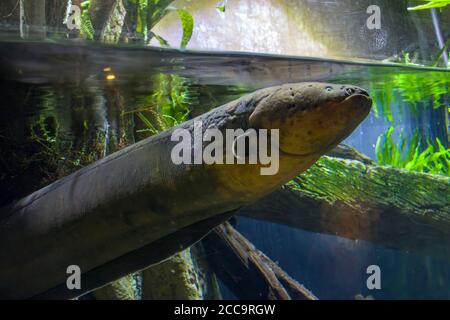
171, 121, 279, 175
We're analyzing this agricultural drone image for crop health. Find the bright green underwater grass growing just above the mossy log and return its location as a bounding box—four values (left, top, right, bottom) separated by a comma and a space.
375, 126, 450, 176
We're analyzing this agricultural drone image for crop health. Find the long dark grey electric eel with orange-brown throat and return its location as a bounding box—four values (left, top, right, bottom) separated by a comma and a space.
0, 83, 372, 299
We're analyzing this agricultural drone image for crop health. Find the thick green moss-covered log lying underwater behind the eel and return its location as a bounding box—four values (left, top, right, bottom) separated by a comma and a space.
239, 157, 450, 257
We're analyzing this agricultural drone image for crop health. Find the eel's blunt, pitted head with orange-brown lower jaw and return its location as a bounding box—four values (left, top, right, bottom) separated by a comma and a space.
249, 83, 372, 156
